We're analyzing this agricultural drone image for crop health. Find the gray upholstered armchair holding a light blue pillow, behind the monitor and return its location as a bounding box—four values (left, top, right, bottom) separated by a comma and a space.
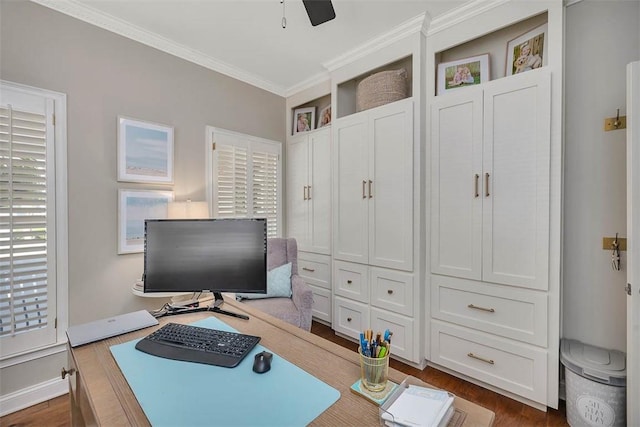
242, 238, 313, 331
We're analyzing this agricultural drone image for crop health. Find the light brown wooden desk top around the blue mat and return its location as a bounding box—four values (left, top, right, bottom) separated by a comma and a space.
69, 300, 495, 427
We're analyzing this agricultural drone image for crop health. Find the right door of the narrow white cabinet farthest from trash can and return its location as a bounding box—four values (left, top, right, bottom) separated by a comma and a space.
307, 128, 331, 255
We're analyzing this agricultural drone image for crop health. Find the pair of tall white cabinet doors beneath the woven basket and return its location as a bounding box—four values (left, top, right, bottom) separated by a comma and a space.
333, 99, 414, 271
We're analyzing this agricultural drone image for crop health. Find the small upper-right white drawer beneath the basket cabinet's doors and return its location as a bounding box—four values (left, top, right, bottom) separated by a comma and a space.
369, 267, 414, 316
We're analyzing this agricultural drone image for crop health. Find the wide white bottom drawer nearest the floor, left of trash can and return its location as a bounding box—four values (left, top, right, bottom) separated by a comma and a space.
431, 320, 547, 405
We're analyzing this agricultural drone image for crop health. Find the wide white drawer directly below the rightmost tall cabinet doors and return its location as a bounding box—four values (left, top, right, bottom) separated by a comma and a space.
431, 275, 547, 347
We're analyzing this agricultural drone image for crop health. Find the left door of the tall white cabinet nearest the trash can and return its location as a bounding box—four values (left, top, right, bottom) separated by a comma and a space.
431, 88, 483, 280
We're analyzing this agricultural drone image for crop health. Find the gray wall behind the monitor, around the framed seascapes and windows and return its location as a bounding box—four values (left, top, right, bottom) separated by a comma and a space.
0, 0, 285, 395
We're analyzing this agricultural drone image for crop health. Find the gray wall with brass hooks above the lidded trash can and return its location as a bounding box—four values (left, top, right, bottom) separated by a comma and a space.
563, 0, 640, 351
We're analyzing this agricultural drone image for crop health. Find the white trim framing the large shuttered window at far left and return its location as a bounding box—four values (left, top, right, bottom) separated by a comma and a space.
0, 80, 69, 368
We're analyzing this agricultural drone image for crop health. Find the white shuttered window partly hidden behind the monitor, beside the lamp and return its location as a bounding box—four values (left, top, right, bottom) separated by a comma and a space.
211, 129, 281, 237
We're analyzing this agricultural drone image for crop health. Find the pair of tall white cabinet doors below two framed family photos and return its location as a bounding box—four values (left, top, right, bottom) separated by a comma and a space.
431, 69, 551, 290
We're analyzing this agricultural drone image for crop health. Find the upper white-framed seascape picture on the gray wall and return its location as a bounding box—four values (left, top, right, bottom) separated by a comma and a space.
118, 116, 173, 184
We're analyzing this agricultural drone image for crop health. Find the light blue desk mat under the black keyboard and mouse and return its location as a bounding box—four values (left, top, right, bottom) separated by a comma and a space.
111, 317, 340, 426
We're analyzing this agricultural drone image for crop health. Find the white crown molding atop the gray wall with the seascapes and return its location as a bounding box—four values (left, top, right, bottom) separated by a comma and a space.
32, 0, 287, 97
